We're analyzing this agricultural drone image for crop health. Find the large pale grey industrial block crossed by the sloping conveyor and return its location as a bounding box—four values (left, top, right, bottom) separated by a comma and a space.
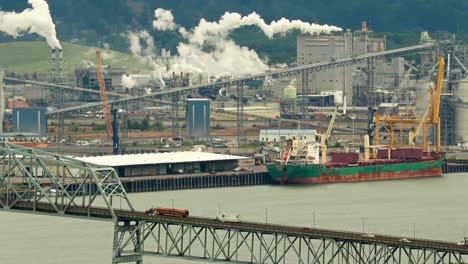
297, 22, 392, 105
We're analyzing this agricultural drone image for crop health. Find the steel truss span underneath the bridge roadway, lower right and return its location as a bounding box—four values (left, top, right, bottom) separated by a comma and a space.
113, 220, 468, 264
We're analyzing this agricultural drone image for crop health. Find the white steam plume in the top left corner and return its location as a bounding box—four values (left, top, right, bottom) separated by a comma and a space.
0, 0, 62, 49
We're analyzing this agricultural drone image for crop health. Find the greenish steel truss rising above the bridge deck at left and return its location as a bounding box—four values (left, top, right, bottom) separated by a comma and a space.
0, 142, 133, 217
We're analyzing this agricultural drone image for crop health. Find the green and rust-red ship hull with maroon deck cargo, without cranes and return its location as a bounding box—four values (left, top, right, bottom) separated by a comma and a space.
266, 137, 444, 184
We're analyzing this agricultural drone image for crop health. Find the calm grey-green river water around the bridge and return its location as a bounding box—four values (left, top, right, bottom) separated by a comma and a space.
0, 174, 468, 264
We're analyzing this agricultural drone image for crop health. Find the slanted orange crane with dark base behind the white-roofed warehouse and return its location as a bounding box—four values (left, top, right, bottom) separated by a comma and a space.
96, 49, 119, 155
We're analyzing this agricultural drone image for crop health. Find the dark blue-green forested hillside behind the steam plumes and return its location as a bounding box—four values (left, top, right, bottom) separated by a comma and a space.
0, 0, 468, 63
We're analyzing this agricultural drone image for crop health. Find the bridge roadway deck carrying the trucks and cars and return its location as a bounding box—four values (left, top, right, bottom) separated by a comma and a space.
0, 201, 468, 255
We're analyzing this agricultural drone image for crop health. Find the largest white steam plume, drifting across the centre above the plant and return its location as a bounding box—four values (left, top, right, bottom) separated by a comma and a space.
153, 8, 342, 76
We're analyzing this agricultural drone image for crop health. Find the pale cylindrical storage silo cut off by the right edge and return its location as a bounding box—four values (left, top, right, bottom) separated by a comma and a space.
454, 80, 468, 141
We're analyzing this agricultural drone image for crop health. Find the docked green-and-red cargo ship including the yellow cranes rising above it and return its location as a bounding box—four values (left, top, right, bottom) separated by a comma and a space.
266, 56, 445, 184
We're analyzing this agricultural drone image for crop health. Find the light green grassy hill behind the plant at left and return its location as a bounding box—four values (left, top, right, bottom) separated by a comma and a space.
0, 41, 145, 76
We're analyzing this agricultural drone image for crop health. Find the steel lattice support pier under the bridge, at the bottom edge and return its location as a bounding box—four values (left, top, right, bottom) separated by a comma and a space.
112, 220, 145, 264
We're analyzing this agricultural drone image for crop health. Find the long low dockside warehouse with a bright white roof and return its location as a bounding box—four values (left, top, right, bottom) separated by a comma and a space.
76, 151, 248, 177
